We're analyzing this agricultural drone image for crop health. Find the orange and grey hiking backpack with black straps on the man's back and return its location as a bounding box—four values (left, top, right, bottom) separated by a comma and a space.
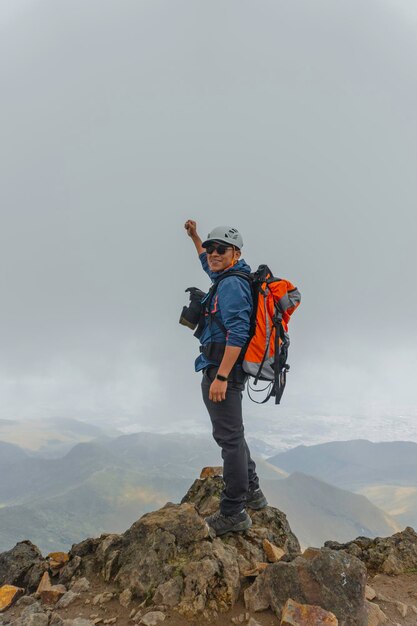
209, 265, 301, 404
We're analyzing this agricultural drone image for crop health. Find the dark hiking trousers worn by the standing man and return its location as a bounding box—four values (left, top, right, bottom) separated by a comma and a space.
201, 366, 259, 515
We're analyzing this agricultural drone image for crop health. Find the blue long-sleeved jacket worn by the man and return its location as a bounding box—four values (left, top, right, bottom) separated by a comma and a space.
195, 252, 253, 372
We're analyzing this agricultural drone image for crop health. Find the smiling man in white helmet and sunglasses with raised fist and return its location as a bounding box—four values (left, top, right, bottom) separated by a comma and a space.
185, 220, 268, 535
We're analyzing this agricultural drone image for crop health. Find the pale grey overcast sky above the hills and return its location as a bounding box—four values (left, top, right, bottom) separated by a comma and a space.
0, 0, 417, 440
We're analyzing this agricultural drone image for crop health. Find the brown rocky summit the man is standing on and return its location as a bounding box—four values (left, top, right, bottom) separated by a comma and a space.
0, 472, 417, 626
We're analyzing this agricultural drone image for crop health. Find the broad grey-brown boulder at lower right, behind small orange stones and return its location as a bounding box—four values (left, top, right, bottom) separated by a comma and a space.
244, 548, 367, 626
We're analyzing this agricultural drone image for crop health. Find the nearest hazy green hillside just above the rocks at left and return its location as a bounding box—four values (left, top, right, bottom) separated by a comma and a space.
0, 469, 190, 554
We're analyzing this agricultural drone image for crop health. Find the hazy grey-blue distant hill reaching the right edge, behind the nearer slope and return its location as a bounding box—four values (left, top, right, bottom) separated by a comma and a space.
268, 439, 417, 491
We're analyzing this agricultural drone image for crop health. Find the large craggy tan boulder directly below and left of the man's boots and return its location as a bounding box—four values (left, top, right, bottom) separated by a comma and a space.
115, 503, 240, 615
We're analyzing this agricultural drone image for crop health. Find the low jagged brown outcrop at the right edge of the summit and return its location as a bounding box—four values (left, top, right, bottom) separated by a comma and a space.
324, 527, 417, 576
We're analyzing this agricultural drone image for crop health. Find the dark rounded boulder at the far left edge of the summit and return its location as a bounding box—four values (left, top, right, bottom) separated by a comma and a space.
0, 541, 47, 591
